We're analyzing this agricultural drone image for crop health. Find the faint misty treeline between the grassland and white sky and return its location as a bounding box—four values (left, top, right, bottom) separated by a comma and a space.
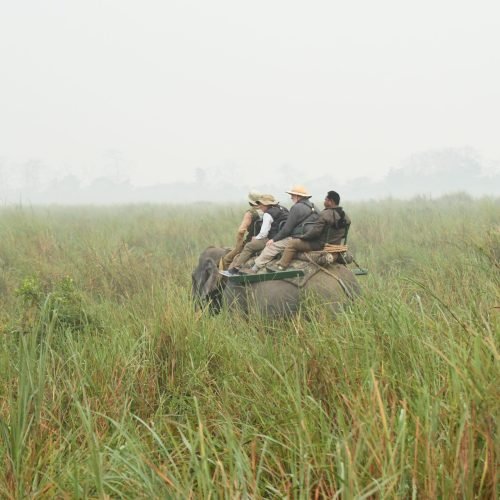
0, 148, 500, 205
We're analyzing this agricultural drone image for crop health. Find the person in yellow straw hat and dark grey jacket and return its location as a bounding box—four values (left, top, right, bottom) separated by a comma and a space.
251, 185, 318, 272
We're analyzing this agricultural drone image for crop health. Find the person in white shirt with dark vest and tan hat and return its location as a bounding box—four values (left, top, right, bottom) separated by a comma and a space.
228, 194, 288, 274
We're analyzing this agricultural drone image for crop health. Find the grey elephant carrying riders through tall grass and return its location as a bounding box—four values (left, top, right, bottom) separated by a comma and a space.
192, 247, 361, 317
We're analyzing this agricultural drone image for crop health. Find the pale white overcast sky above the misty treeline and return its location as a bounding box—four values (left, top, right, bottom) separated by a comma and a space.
0, 0, 500, 185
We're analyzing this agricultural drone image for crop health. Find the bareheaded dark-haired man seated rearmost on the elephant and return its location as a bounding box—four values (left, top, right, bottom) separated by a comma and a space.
269, 191, 351, 271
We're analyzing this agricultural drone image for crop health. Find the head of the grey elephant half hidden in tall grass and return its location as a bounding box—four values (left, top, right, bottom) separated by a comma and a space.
191, 247, 229, 313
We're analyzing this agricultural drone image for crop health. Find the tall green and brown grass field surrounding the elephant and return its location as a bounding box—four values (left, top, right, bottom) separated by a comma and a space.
0, 195, 500, 498
